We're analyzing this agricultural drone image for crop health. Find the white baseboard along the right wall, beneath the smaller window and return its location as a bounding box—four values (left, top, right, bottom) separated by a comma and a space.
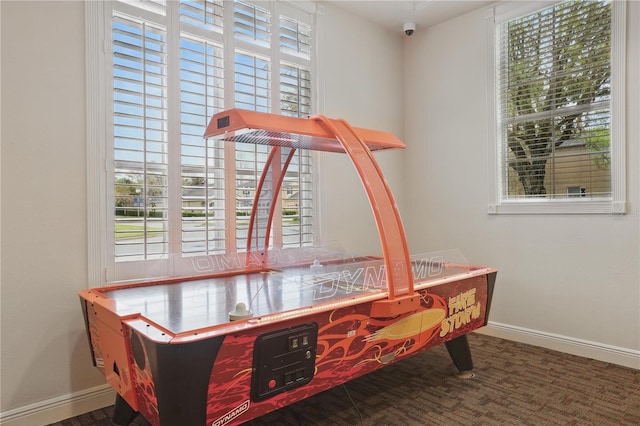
476, 321, 640, 370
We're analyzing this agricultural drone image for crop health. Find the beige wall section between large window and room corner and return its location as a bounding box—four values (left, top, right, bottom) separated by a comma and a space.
317, 4, 404, 254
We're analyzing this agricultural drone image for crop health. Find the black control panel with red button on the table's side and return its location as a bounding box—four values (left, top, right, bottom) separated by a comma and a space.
251, 322, 318, 401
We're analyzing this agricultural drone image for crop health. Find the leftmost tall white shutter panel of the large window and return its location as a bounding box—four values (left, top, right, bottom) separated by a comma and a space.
112, 14, 168, 260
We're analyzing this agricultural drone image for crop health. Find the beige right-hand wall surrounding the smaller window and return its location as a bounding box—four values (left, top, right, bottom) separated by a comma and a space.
404, 2, 640, 362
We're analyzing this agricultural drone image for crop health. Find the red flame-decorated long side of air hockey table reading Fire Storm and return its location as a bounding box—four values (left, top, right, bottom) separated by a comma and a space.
111, 272, 495, 426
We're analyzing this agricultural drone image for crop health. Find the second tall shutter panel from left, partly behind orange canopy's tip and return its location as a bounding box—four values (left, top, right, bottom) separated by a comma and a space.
180, 35, 226, 255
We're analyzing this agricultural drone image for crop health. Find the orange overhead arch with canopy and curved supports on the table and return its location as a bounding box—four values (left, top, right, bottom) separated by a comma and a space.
204, 109, 420, 317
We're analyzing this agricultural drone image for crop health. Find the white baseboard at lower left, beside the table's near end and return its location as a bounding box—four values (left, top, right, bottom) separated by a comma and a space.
0, 385, 116, 426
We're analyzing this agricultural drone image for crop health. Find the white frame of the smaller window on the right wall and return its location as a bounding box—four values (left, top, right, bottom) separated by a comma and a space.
486, 0, 627, 214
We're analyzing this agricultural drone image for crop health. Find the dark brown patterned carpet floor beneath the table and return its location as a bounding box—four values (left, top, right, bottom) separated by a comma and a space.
51, 334, 640, 426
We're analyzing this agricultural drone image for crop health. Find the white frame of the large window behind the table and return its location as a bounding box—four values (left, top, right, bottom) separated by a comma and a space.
85, 0, 318, 287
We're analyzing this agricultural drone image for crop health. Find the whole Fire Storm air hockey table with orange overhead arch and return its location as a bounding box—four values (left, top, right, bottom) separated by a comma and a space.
79, 109, 497, 426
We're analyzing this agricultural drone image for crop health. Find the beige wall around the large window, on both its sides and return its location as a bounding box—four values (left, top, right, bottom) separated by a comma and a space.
0, 1, 402, 426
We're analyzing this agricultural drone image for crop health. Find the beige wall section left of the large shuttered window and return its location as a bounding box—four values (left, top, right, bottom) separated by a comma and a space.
0, 1, 109, 420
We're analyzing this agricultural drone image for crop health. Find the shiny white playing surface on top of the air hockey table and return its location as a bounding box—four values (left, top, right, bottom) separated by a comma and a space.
101, 251, 488, 336
